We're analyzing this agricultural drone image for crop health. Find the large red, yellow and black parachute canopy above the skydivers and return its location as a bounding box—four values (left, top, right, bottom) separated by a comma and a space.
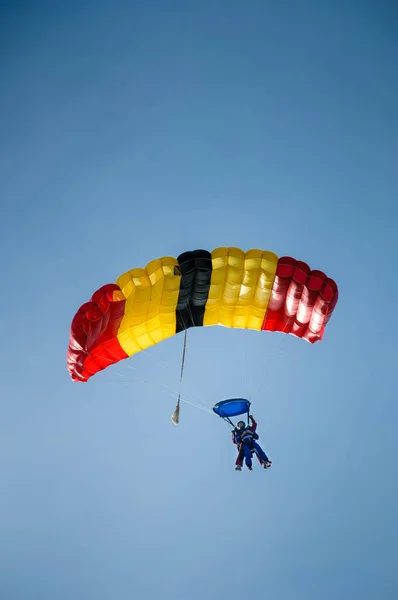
67, 248, 338, 381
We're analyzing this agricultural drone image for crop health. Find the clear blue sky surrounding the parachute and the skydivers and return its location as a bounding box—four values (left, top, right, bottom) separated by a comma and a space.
0, 0, 398, 600
